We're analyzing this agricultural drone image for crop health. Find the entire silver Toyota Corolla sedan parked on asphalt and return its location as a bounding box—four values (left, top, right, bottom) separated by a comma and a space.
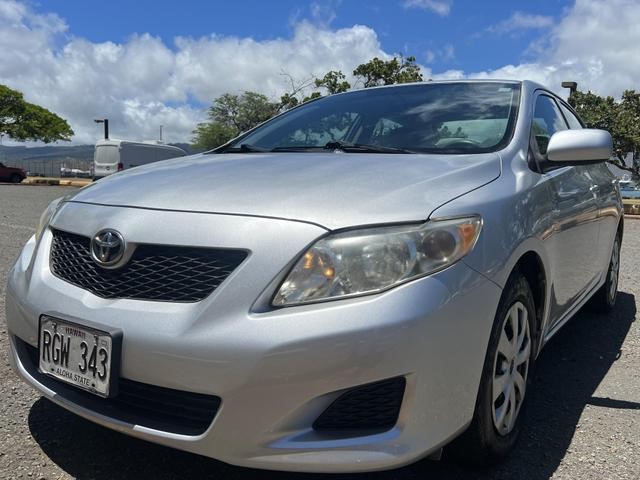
6, 81, 623, 472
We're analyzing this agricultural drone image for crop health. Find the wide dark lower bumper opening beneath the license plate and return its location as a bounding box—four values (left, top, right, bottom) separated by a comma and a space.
16, 337, 221, 435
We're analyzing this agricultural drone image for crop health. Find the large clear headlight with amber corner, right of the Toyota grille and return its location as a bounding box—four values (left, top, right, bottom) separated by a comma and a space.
273, 216, 482, 306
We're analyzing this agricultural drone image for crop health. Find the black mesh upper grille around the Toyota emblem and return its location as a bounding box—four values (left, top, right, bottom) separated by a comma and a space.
50, 230, 247, 302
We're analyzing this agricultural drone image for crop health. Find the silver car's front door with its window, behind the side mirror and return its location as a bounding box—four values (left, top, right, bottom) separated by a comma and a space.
531, 93, 599, 324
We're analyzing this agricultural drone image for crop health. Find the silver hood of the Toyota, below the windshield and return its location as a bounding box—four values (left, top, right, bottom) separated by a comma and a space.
72, 152, 500, 230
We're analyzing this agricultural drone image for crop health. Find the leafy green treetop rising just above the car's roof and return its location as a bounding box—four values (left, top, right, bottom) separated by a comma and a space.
353, 55, 423, 88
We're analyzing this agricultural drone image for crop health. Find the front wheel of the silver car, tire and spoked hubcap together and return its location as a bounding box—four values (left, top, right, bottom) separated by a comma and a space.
450, 272, 536, 464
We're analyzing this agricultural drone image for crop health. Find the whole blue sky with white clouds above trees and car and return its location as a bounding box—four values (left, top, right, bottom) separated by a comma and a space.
0, 0, 640, 144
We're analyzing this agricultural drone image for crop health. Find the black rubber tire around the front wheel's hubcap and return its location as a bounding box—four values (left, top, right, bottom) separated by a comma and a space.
446, 271, 537, 465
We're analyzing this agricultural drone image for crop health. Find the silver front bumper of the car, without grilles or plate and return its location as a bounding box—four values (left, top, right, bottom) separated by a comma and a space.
6, 203, 501, 472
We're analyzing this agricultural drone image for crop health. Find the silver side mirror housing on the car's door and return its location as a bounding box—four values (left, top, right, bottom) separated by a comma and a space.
547, 128, 613, 165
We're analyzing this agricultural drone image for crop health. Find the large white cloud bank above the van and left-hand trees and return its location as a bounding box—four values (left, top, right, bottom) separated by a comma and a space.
0, 0, 388, 143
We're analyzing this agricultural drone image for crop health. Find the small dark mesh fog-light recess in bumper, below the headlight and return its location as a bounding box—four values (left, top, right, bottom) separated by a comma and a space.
313, 377, 406, 431
